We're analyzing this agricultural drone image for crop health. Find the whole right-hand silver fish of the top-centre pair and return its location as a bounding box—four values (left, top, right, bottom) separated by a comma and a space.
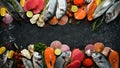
56, 0, 67, 19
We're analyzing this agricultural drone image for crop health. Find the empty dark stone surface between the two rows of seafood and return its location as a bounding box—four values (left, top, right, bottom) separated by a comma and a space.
0, 15, 120, 52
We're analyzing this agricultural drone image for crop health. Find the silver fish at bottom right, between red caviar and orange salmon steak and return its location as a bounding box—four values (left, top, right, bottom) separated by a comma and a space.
92, 52, 112, 68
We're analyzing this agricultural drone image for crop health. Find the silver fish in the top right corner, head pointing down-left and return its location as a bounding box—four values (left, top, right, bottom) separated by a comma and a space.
105, 1, 120, 23
